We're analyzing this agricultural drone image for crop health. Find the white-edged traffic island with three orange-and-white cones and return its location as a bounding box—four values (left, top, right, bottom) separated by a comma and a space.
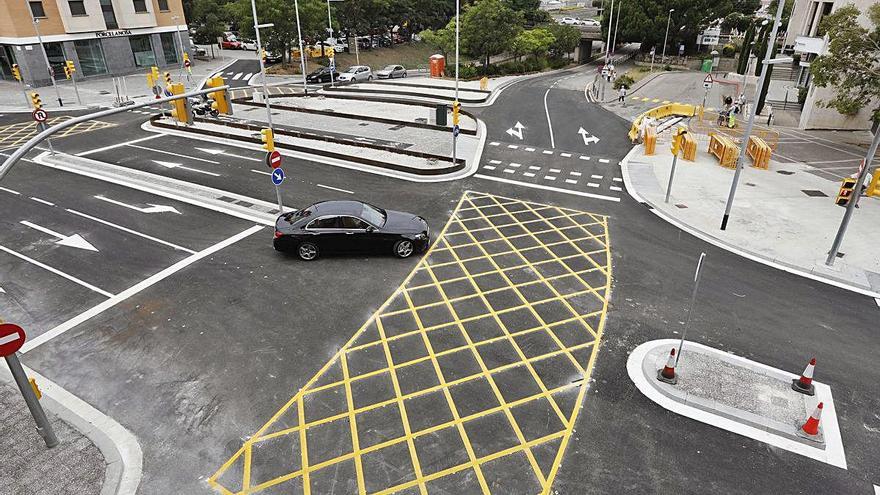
627, 339, 846, 469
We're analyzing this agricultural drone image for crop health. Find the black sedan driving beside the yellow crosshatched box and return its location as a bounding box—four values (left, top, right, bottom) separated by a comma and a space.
273, 201, 430, 261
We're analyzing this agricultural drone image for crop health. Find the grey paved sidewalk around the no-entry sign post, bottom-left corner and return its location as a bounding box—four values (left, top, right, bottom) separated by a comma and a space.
0, 382, 105, 495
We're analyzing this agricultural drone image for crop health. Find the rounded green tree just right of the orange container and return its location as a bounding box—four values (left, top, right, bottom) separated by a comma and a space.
460, 0, 524, 73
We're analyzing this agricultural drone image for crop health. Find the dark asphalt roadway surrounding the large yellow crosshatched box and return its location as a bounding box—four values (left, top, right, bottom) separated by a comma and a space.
0, 62, 880, 495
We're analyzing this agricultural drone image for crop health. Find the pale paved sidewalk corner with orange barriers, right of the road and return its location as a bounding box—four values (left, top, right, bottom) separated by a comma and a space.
621, 140, 880, 297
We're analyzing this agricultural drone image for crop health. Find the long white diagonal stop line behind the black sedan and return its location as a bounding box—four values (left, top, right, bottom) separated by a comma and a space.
19, 225, 263, 354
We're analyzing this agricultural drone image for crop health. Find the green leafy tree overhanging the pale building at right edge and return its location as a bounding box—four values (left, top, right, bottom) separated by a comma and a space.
810, 3, 880, 124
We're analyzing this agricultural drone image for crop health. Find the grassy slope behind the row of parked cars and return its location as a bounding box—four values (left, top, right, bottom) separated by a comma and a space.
267, 43, 436, 74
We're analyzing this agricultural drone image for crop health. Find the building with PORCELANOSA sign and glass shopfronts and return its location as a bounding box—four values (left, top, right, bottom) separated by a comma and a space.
0, 0, 190, 86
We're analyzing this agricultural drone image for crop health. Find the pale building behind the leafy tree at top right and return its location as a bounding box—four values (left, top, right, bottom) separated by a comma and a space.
785, 0, 877, 130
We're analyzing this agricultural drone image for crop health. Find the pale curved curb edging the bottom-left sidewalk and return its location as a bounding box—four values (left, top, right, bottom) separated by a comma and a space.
0, 366, 143, 495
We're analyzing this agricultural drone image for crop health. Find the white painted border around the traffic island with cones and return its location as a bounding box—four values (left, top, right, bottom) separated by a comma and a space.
626, 339, 846, 469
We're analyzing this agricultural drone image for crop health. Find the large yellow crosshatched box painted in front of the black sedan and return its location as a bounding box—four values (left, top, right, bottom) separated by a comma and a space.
209, 192, 611, 494
